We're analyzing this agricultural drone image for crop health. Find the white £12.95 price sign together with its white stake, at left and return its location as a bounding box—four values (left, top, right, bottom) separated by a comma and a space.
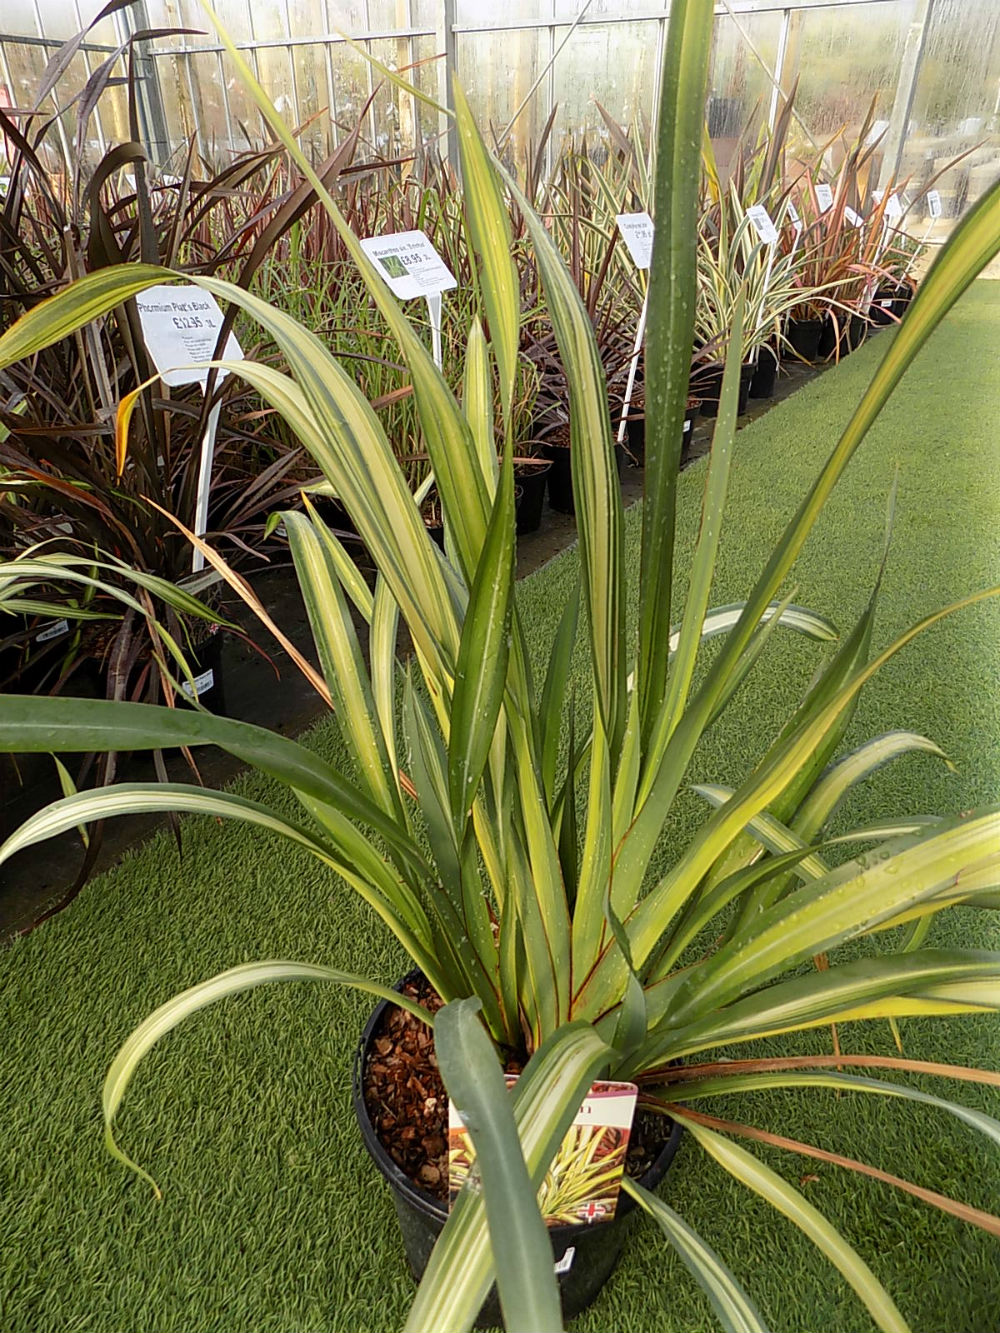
136, 284, 243, 573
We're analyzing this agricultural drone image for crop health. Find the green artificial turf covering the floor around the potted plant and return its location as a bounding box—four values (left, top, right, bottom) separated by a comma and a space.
0, 283, 1000, 1333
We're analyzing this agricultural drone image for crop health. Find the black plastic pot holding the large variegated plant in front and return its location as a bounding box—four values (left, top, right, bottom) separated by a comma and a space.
351, 973, 683, 1328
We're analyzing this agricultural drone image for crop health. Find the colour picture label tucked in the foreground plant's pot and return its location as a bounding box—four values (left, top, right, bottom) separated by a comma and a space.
448, 1074, 639, 1221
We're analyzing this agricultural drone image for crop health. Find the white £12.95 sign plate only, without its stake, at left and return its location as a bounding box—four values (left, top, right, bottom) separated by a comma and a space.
136, 283, 243, 389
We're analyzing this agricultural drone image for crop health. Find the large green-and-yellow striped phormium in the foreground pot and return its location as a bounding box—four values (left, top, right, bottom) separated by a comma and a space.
0, 0, 1000, 1333
